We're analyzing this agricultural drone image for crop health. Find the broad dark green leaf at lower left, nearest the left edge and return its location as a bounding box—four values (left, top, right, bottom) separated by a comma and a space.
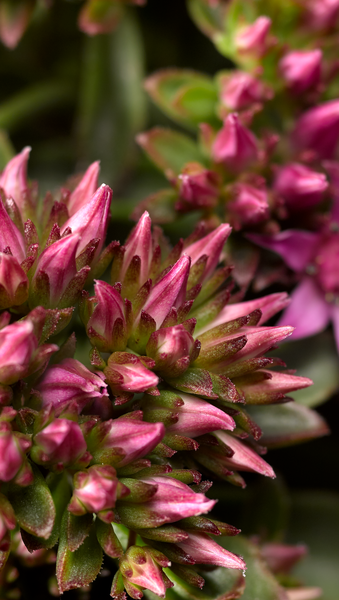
8, 464, 56, 540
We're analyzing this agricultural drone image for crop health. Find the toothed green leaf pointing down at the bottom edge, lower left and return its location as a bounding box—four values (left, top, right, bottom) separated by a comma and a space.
56, 509, 102, 594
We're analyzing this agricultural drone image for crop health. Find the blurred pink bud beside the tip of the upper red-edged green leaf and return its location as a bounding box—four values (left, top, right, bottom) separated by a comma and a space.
220, 71, 273, 110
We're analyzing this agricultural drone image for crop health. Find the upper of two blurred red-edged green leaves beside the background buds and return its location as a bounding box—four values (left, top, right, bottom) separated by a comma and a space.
145, 69, 218, 127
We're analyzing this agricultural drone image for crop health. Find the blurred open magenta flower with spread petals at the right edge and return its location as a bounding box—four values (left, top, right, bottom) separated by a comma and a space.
249, 229, 339, 349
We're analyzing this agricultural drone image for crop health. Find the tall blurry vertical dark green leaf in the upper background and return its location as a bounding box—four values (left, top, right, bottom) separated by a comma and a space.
77, 10, 146, 184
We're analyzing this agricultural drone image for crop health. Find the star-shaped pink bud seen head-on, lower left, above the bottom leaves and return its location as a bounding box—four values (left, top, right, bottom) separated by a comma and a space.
68, 465, 128, 522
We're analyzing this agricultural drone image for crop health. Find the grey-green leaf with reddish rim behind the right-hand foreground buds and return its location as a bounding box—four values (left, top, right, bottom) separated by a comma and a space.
247, 402, 329, 448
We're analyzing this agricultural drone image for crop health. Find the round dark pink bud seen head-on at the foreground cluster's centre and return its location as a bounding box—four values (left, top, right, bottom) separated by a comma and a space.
146, 325, 200, 377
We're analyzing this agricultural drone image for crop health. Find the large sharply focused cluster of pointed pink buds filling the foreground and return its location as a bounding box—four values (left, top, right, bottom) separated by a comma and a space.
0, 148, 327, 600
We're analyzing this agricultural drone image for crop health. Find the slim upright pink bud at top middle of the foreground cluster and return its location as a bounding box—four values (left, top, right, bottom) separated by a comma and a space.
119, 211, 153, 286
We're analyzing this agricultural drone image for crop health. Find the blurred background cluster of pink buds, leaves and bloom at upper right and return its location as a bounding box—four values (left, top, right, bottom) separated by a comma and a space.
135, 0, 339, 356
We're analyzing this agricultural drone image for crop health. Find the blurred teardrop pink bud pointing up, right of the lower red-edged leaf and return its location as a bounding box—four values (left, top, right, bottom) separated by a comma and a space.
212, 113, 258, 172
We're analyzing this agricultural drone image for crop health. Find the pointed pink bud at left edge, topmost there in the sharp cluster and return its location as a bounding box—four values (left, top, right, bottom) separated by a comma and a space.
0, 146, 31, 216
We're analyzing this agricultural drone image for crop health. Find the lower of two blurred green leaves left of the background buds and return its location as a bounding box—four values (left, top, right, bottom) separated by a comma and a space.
137, 127, 204, 179
